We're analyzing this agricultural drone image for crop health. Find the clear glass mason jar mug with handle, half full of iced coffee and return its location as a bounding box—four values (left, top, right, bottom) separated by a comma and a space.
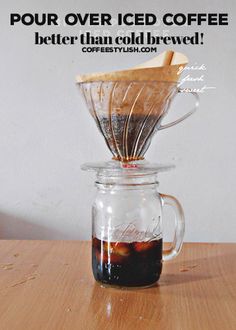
88, 166, 184, 287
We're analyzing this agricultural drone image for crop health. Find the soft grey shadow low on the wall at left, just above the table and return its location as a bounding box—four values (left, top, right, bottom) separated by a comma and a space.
0, 212, 62, 239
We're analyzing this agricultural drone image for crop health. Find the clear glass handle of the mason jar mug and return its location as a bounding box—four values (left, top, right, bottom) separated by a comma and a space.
160, 194, 185, 261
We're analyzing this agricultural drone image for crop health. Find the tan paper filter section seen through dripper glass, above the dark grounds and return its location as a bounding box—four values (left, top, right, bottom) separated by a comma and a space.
80, 80, 176, 116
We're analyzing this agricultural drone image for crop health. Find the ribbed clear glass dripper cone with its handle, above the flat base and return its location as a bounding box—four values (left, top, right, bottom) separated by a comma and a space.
78, 81, 199, 162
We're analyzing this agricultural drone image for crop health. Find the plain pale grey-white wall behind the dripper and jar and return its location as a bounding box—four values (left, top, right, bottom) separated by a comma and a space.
0, 0, 236, 242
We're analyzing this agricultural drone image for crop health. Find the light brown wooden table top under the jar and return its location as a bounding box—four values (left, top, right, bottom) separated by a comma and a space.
0, 241, 236, 330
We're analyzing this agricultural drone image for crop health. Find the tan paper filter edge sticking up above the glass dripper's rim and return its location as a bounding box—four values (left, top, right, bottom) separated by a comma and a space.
76, 50, 188, 83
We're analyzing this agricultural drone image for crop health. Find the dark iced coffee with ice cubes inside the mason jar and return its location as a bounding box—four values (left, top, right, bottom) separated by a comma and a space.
92, 237, 162, 286
